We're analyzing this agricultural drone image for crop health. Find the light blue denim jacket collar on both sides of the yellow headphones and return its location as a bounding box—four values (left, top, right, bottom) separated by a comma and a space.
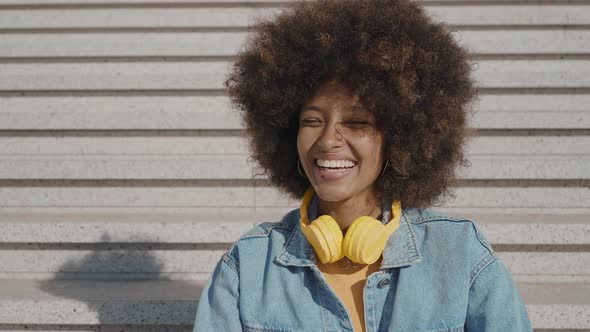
275, 196, 422, 270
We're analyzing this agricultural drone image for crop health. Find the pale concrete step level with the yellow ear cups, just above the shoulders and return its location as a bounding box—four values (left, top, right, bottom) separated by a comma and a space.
0, 209, 590, 245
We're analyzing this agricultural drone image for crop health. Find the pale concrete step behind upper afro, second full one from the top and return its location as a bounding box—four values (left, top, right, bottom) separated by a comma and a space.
0, 30, 590, 58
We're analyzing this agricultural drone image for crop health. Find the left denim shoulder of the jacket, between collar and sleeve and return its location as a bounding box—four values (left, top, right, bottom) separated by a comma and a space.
222, 209, 299, 269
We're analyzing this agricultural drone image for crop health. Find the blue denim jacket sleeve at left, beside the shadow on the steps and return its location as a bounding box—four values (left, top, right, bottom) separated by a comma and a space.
193, 259, 242, 332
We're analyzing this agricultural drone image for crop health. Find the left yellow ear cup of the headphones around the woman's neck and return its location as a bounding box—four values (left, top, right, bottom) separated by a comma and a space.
305, 215, 344, 264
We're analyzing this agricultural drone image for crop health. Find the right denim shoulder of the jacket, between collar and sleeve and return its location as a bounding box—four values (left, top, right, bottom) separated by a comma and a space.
404, 209, 498, 278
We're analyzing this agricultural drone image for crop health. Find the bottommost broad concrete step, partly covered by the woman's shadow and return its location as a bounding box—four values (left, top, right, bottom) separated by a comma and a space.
0, 279, 590, 330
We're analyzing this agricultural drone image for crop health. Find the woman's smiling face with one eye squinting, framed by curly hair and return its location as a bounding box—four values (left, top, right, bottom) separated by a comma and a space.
297, 81, 383, 202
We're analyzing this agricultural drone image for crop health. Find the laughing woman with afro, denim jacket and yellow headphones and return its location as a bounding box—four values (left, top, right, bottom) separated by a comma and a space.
194, 0, 532, 332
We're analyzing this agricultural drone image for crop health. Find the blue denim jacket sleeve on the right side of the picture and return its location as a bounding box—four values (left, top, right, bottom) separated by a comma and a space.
465, 258, 533, 332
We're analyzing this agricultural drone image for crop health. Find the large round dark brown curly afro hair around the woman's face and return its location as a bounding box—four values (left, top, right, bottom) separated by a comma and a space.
225, 0, 477, 207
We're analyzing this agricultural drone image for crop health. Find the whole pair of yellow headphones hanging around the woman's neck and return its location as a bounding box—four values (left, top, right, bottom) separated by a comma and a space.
299, 187, 402, 264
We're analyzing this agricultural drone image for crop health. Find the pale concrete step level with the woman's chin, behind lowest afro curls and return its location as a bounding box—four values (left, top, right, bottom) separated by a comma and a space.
0, 185, 590, 209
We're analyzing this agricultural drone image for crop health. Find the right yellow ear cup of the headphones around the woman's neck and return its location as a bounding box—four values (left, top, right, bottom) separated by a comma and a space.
342, 216, 385, 264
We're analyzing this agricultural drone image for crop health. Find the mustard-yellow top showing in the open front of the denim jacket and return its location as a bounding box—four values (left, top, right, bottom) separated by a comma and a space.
317, 257, 382, 332
